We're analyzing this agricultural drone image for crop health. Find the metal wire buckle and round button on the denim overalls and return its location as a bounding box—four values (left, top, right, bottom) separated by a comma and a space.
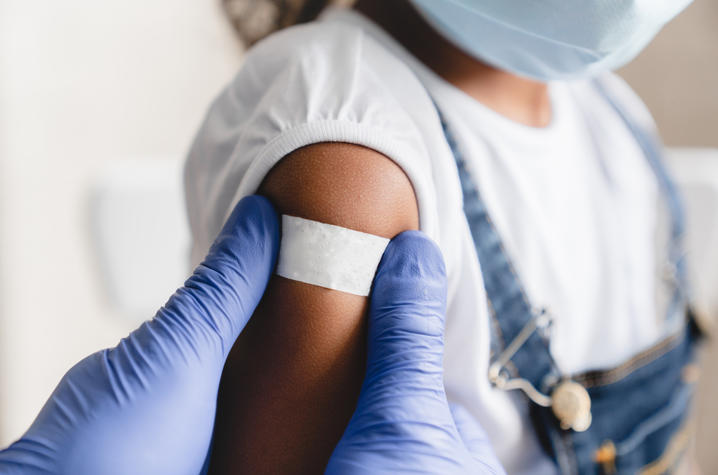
489, 309, 592, 432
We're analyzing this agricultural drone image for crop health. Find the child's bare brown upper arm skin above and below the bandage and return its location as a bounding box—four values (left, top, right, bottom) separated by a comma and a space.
211, 143, 419, 473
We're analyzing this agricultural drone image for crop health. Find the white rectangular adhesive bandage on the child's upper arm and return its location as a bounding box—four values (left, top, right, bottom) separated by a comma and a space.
277, 215, 389, 296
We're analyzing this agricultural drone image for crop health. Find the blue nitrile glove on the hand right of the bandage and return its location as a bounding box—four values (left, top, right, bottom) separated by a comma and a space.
326, 231, 504, 475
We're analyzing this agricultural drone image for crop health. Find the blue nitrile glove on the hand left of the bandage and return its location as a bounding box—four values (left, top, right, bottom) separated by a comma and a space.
0, 196, 279, 475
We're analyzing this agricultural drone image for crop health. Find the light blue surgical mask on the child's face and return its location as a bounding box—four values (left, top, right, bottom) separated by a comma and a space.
411, 0, 692, 81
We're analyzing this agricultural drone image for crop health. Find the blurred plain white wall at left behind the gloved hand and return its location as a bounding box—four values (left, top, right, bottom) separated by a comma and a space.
0, 0, 241, 446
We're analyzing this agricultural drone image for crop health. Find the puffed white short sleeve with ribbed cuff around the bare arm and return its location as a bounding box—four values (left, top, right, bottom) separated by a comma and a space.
185, 22, 437, 264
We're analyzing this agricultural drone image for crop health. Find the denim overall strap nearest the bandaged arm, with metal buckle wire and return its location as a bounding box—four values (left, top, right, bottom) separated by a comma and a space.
437, 107, 559, 400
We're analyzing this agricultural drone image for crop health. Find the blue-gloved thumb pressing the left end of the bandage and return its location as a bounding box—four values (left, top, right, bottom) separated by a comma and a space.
150, 196, 279, 357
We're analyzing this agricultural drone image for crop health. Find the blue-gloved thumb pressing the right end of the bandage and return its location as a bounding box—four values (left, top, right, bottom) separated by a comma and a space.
345, 231, 453, 437
